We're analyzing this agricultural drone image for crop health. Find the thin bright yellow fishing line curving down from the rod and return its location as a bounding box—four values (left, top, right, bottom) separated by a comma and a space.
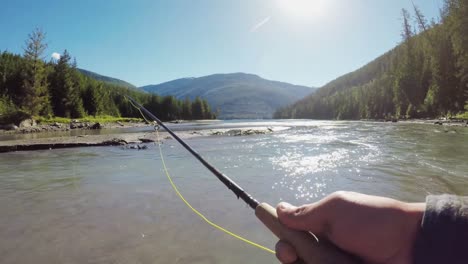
128, 100, 275, 254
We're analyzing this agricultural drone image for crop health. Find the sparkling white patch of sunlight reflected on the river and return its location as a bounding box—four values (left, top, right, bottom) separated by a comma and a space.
270, 122, 381, 201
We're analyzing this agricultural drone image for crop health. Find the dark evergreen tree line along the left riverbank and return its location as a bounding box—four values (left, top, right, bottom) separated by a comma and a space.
0, 29, 216, 123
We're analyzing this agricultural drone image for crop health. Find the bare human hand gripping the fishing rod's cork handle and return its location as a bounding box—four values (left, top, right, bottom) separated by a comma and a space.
276, 192, 426, 264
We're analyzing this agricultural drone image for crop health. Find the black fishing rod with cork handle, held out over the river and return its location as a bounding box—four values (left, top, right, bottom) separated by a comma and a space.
125, 95, 358, 264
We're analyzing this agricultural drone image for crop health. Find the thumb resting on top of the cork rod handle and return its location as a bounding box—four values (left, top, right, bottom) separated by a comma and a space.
276, 203, 327, 234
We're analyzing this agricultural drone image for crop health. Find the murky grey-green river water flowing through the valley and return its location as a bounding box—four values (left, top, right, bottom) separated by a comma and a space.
0, 120, 468, 263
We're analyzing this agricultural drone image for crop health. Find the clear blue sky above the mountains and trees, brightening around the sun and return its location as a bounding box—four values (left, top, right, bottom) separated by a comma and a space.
0, 0, 442, 86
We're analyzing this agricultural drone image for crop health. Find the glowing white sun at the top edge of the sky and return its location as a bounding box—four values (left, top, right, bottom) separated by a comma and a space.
277, 0, 330, 21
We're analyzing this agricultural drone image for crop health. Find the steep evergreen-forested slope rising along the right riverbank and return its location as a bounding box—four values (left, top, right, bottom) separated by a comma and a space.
275, 0, 468, 119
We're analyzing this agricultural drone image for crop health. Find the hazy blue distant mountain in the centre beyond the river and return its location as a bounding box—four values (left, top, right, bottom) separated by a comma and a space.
140, 73, 315, 119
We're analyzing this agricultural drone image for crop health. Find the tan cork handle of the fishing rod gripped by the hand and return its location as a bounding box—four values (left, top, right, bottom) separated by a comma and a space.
255, 203, 360, 264
